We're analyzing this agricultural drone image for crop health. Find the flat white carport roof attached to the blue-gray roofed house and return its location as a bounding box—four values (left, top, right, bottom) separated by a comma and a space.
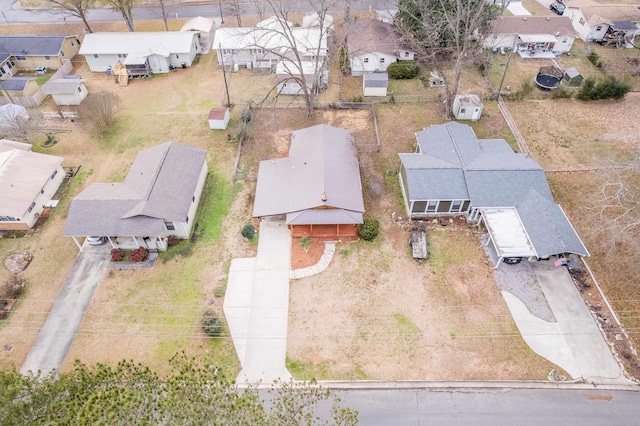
480, 207, 537, 257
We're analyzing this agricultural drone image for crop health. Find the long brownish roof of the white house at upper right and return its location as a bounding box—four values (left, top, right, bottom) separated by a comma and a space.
491, 16, 576, 36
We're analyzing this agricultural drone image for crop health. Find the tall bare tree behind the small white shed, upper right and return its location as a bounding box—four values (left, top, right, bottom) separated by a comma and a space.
396, 0, 498, 119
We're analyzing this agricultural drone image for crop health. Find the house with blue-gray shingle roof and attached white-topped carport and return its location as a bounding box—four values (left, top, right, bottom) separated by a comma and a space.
399, 122, 589, 266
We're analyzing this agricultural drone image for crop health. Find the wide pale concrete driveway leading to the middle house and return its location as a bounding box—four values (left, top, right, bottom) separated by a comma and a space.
224, 219, 291, 383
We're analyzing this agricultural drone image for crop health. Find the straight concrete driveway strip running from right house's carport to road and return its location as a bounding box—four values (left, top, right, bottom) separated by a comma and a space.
531, 262, 629, 384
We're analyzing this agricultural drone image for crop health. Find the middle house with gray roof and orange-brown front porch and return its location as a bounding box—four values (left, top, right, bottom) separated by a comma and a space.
253, 124, 364, 237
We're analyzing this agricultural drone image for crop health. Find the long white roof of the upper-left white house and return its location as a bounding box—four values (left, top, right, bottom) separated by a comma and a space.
78, 31, 197, 56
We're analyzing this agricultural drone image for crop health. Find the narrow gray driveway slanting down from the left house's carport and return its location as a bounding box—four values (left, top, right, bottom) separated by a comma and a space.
20, 245, 111, 375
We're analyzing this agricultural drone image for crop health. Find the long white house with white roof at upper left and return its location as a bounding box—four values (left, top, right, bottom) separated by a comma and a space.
79, 31, 200, 74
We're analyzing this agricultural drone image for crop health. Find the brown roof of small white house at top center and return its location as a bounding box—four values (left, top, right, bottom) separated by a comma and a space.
347, 18, 400, 56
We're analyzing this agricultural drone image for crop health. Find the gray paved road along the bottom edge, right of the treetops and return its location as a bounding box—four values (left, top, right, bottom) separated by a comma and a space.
336, 388, 640, 426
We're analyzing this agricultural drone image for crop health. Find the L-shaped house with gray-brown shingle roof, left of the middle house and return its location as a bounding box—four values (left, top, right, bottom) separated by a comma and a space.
63, 142, 207, 250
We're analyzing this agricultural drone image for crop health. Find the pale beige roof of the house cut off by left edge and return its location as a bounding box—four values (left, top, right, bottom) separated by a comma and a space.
0, 148, 62, 217
